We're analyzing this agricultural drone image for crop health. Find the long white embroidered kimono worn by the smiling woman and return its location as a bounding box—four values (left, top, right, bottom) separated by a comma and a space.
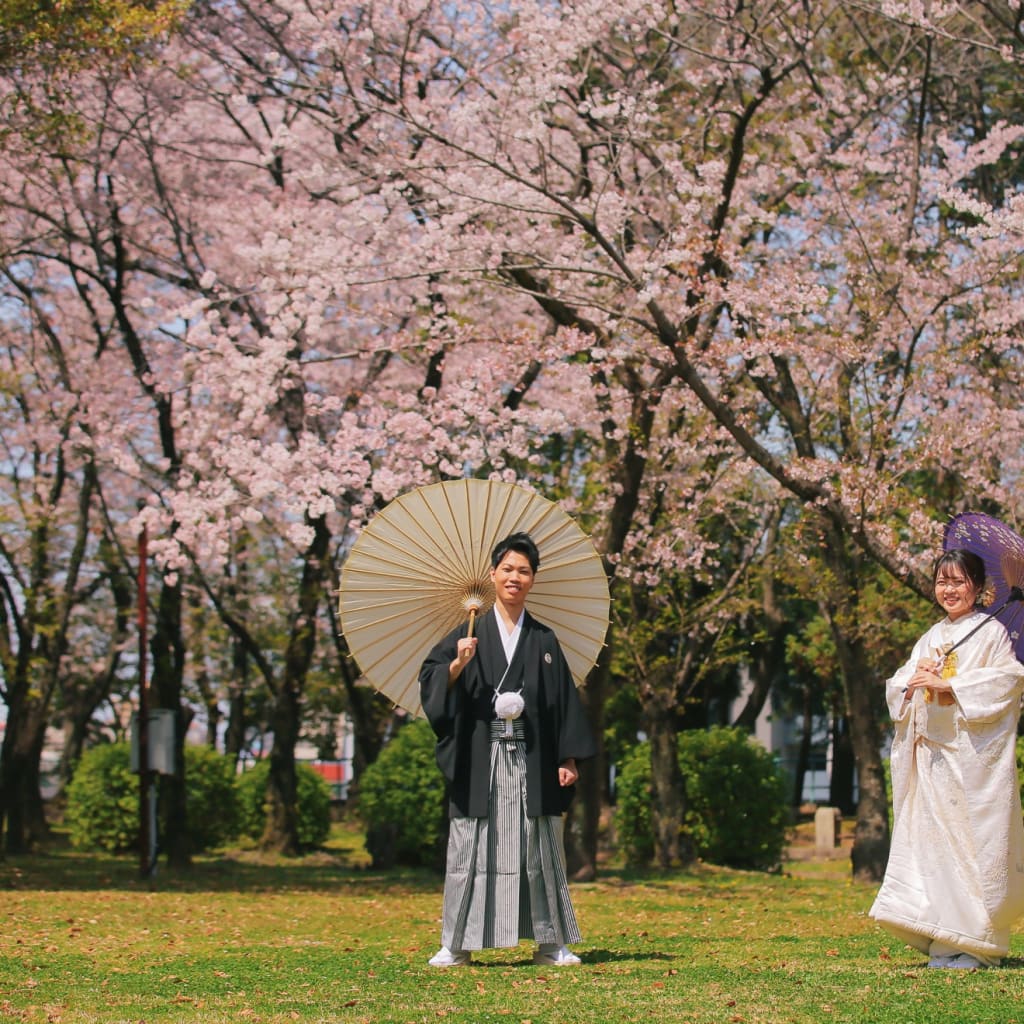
870, 611, 1024, 965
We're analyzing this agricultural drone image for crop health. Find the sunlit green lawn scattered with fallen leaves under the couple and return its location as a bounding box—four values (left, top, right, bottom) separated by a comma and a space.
0, 831, 1024, 1024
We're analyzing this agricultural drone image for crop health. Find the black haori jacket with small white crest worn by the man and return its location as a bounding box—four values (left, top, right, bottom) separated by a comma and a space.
420, 610, 597, 818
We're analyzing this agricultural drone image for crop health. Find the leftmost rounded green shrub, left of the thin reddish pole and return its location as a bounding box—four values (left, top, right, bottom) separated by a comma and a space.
66, 743, 139, 853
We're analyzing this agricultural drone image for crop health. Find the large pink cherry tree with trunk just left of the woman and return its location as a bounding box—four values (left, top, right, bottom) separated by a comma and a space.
178, 0, 1021, 877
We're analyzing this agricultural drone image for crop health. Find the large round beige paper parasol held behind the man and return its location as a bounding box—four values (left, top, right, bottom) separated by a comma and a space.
338, 479, 608, 715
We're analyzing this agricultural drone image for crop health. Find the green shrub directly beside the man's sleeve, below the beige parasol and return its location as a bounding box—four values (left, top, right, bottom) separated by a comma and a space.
359, 720, 447, 868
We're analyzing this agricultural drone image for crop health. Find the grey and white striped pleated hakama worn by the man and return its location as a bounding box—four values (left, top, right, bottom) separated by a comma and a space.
441, 719, 581, 950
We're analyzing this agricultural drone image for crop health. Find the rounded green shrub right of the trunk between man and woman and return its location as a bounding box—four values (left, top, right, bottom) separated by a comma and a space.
679, 727, 790, 870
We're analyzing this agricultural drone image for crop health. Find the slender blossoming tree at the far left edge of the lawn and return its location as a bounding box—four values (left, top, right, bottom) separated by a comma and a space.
0, 260, 124, 853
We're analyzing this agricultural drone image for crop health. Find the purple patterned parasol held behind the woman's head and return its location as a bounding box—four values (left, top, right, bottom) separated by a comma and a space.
942, 512, 1024, 662
